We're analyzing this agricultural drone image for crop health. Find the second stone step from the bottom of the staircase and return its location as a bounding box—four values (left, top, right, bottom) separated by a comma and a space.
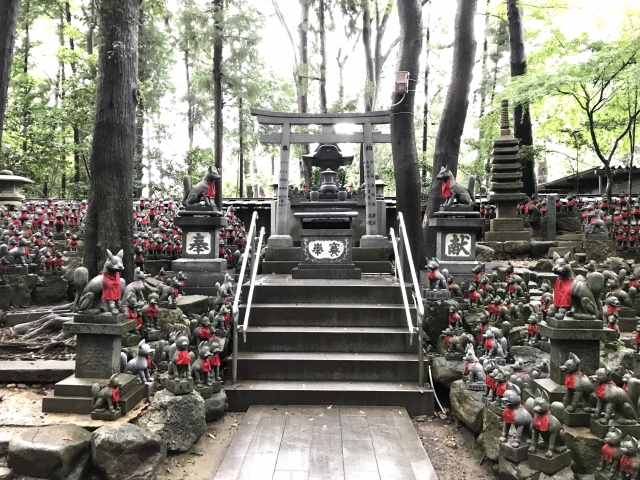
238, 352, 418, 383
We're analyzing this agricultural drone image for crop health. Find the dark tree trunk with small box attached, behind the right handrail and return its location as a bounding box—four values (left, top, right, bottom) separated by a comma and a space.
391, 0, 424, 277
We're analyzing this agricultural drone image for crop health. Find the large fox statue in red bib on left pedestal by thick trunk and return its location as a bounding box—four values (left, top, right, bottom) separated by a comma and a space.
73, 249, 126, 315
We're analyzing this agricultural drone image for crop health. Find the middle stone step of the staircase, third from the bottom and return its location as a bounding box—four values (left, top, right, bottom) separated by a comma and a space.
240, 326, 418, 353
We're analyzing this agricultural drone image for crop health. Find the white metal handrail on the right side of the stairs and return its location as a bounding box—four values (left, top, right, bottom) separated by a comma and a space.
389, 212, 424, 387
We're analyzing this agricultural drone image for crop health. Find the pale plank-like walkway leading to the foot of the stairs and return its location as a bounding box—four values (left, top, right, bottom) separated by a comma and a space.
215, 406, 438, 480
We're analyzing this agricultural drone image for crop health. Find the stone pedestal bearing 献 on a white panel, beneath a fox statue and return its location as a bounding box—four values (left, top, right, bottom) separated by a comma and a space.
429, 210, 485, 284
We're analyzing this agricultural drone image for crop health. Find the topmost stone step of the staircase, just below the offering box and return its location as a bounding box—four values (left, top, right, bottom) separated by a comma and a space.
242, 275, 411, 305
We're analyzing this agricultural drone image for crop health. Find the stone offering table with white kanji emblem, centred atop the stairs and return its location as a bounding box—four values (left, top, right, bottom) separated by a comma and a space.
291, 211, 362, 279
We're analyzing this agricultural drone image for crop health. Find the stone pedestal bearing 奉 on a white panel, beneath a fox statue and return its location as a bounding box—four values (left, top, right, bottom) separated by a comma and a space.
171, 209, 227, 296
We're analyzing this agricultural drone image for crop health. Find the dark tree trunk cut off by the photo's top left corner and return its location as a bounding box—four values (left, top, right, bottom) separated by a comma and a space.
0, 0, 20, 148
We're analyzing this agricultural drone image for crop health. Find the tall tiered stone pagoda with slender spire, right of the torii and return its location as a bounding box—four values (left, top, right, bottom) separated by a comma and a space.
484, 100, 531, 242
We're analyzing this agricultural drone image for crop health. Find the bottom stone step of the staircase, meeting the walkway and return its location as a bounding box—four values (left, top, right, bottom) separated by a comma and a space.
225, 380, 434, 416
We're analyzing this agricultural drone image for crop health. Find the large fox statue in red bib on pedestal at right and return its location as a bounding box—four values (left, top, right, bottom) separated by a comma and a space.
547, 252, 604, 320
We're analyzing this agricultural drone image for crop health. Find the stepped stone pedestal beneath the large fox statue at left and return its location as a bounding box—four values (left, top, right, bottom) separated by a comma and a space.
42, 314, 146, 415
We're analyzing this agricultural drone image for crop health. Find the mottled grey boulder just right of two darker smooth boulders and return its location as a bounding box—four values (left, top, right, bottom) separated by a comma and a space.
138, 390, 207, 452
